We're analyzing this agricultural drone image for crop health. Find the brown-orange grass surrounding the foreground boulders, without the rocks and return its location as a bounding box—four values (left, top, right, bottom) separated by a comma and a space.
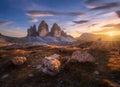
0, 43, 120, 87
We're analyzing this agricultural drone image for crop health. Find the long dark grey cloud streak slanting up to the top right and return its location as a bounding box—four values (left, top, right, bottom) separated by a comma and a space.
90, 2, 120, 10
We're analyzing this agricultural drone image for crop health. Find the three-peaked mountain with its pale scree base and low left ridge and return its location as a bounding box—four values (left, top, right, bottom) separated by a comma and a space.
0, 20, 76, 45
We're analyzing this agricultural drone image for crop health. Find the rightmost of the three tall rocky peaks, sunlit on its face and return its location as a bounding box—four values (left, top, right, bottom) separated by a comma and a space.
50, 23, 61, 37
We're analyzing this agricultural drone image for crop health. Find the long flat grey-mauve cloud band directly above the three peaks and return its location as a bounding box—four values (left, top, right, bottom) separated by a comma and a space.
27, 10, 84, 17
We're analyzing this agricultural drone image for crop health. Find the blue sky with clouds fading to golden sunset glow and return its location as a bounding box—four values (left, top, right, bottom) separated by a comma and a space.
0, 0, 120, 37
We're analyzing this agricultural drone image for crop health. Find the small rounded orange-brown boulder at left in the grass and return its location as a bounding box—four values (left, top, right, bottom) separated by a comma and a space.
11, 57, 27, 65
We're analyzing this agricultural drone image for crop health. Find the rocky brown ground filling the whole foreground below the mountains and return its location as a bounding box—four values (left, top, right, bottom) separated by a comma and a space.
0, 45, 120, 87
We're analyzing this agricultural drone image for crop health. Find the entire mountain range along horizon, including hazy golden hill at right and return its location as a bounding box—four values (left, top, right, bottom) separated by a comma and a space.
0, 20, 120, 45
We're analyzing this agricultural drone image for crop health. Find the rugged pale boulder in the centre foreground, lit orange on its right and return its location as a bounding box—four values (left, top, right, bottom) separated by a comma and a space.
37, 54, 61, 75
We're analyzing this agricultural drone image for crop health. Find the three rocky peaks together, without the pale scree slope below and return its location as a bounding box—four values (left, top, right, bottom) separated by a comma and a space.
27, 20, 68, 37
